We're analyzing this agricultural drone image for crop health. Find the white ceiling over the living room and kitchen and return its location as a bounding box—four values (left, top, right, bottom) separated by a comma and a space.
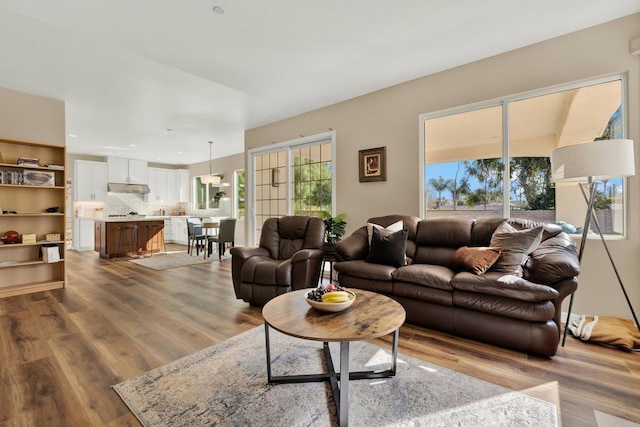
0, 0, 640, 165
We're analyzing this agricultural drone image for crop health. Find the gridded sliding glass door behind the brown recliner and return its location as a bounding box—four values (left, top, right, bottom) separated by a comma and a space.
247, 131, 335, 242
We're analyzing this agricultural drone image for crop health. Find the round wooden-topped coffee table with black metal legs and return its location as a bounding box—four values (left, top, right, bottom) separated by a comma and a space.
262, 289, 406, 426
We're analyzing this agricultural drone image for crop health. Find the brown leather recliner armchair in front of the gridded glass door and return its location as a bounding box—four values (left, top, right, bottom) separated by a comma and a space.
230, 216, 324, 305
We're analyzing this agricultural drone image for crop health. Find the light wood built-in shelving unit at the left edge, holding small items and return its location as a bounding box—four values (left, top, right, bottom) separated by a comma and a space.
0, 139, 66, 298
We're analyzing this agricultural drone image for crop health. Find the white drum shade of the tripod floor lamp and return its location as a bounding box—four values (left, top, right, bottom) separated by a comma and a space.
551, 139, 636, 181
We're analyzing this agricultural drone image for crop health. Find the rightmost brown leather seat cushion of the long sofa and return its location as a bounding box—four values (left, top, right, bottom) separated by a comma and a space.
451, 271, 558, 302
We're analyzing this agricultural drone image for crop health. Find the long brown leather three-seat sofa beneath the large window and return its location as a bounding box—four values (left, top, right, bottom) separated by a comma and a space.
335, 215, 579, 356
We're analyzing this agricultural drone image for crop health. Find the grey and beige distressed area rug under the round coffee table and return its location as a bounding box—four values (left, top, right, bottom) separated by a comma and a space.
113, 326, 557, 427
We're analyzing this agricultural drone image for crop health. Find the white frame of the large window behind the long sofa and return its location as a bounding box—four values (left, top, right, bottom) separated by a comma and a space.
418, 73, 629, 240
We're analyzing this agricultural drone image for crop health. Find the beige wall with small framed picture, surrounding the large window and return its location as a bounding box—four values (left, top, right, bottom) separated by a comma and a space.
245, 14, 640, 317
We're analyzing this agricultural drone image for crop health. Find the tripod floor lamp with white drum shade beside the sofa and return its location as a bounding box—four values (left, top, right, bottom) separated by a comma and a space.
551, 139, 640, 346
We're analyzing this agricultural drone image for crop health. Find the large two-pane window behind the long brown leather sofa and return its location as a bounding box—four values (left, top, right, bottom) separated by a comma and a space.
421, 76, 626, 235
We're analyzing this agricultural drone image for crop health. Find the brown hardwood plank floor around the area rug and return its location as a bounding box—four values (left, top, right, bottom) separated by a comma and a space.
0, 245, 640, 427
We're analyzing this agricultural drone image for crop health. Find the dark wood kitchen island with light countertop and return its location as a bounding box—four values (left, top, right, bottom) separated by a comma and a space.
94, 215, 169, 258
